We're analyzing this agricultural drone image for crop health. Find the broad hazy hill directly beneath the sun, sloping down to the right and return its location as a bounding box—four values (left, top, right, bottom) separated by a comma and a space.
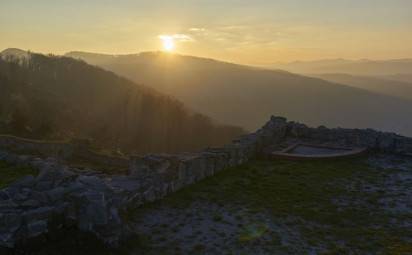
66, 52, 412, 135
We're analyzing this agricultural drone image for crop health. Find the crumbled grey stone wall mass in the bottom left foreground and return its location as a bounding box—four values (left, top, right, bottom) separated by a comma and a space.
0, 151, 125, 248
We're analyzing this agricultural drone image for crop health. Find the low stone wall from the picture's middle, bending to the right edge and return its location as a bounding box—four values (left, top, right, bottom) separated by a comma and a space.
125, 117, 412, 206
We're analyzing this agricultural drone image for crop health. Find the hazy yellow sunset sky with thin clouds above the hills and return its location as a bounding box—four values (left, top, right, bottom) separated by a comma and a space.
0, 0, 412, 64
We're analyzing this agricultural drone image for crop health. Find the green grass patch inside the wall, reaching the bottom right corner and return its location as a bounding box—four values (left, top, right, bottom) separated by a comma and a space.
138, 158, 412, 254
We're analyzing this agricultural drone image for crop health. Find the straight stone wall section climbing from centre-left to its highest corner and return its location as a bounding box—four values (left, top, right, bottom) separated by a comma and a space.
128, 117, 287, 207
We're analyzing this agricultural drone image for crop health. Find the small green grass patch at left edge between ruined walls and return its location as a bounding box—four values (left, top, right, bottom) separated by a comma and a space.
0, 161, 38, 189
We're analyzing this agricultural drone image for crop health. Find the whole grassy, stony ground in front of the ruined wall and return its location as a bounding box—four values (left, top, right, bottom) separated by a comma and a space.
3, 152, 412, 254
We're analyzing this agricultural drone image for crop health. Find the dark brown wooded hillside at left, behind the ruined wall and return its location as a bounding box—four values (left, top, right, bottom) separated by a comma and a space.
0, 50, 244, 153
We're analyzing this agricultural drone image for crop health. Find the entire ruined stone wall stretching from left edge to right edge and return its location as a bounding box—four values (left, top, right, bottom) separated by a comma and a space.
0, 117, 412, 248
